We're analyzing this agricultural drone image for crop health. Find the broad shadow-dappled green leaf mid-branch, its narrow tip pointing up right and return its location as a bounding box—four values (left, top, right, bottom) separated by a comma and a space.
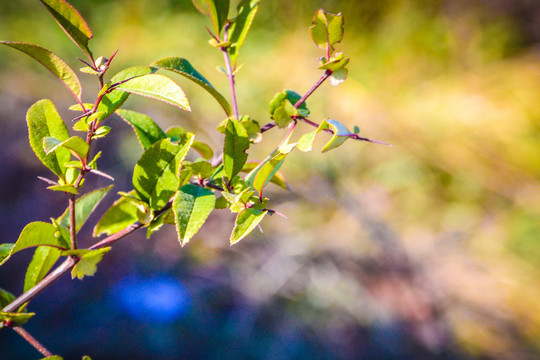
133, 138, 194, 210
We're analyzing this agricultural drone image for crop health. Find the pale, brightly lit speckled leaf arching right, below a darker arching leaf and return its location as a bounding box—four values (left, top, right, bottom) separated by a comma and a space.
117, 74, 191, 111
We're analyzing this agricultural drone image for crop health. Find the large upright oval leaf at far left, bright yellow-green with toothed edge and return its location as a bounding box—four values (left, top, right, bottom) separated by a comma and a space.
26, 100, 71, 179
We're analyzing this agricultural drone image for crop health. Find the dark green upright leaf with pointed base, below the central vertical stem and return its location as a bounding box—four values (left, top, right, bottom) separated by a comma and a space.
223, 118, 249, 179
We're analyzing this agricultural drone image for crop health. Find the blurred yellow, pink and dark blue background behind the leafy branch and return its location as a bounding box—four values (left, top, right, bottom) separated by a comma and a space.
0, 0, 540, 359
